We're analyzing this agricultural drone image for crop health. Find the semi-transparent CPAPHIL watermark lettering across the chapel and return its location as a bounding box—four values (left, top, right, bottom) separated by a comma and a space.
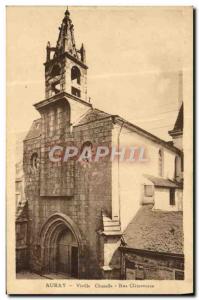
49, 142, 149, 163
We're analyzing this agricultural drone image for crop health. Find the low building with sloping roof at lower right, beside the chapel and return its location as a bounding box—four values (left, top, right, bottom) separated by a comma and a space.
120, 205, 184, 280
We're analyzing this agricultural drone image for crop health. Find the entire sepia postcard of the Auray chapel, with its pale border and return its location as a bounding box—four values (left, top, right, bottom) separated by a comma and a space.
6, 6, 193, 294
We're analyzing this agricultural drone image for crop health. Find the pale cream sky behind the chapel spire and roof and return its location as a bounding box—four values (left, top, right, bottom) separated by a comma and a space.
7, 6, 190, 145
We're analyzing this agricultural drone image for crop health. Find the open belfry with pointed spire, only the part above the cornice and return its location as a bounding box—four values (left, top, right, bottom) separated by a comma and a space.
44, 9, 88, 101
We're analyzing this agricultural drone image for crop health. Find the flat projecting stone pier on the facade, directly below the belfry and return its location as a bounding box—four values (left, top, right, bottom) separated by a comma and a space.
40, 99, 74, 196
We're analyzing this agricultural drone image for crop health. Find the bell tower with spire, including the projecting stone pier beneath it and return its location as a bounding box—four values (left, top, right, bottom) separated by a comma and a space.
34, 9, 92, 197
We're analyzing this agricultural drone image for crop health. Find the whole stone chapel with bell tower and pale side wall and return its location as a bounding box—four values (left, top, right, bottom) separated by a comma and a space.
17, 10, 182, 279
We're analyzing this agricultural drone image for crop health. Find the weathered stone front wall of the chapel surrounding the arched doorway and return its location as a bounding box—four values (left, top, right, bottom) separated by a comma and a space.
24, 109, 112, 278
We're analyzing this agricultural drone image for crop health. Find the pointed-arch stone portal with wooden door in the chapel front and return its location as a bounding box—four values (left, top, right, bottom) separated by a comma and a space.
40, 213, 82, 278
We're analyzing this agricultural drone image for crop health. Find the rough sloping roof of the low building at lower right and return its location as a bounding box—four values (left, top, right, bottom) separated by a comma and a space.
123, 205, 184, 254
